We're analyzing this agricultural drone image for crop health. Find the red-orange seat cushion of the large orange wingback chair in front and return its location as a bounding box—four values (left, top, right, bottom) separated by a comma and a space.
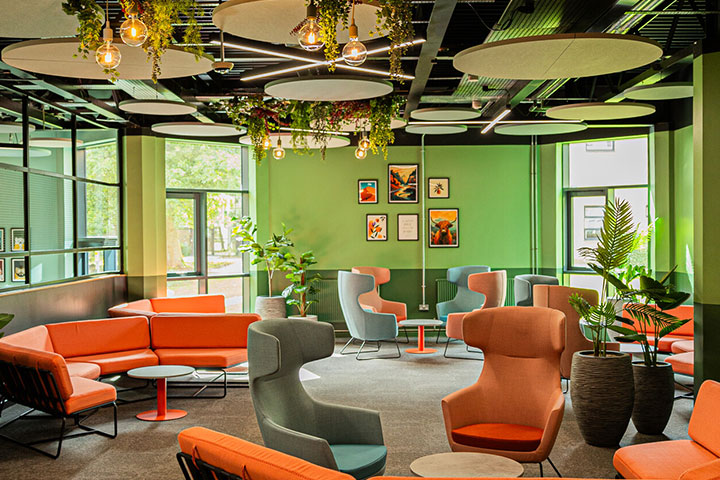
452, 423, 543, 452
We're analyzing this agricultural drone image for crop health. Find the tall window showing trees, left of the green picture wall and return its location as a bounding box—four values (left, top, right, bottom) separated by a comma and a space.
165, 140, 249, 312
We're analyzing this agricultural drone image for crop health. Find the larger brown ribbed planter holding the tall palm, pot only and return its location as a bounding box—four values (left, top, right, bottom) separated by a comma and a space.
570, 351, 635, 447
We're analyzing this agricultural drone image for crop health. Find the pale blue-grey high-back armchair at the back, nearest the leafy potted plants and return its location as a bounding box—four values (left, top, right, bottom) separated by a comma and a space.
338, 271, 400, 360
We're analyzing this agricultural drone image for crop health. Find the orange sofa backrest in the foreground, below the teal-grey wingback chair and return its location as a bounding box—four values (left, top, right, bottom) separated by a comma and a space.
178, 427, 354, 480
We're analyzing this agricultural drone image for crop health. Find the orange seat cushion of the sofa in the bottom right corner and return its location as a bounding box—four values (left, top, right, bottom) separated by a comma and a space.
613, 440, 717, 478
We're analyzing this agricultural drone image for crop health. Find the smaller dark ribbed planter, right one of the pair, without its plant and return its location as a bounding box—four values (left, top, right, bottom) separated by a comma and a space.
632, 362, 675, 435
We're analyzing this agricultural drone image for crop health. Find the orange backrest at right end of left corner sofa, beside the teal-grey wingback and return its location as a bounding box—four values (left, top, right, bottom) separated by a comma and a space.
150, 313, 260, 349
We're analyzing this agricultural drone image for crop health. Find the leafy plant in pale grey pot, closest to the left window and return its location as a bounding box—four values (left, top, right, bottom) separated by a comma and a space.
233, 217, 293, 320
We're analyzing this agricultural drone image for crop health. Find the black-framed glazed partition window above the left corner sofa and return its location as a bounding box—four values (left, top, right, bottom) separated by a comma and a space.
0, 112, 121, 291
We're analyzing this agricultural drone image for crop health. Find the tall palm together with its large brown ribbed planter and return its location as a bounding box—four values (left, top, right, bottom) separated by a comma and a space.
570, 199, 636, 447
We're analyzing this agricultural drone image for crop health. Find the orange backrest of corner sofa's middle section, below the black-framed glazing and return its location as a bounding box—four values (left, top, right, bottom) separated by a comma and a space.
47, 317, 150, 358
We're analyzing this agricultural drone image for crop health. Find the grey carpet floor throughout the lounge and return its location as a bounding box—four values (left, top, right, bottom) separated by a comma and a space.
0, 344, 693, 480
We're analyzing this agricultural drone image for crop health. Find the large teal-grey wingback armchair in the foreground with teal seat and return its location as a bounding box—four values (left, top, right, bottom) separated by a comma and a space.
248, 319, 387, 479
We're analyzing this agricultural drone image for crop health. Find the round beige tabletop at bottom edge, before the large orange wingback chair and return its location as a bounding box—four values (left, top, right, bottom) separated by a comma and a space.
410, 452, 525, 478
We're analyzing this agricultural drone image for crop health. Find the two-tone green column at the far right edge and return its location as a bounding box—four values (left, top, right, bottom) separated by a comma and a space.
693, 51, 720, 386
